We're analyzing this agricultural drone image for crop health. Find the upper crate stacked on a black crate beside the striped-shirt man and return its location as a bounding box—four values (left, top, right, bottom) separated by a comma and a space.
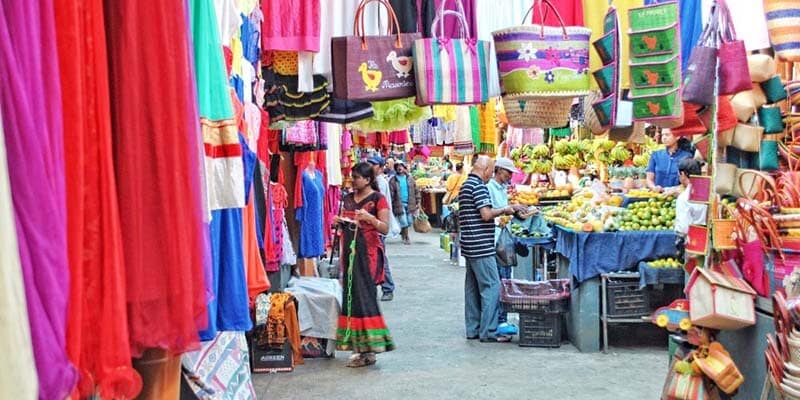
500, 279, 570, 313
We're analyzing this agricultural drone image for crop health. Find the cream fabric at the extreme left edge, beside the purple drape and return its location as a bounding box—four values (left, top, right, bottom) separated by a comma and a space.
0, 110, 39, 400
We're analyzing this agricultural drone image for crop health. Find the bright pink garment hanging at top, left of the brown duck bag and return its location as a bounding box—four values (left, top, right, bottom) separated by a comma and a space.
261, 0, 321, 52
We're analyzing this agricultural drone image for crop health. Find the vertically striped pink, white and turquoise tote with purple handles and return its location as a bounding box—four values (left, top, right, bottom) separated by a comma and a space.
412, 0, 499, 105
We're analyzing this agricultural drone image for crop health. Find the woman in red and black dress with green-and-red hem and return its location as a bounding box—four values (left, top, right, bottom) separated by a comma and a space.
336, 163, 395, 367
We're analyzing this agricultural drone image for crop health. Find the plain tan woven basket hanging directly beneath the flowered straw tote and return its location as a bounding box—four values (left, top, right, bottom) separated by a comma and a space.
503, 96, 572, 128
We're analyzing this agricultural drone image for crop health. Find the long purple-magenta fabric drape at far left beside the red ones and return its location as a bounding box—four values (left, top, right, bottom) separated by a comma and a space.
0, 0, 77, 399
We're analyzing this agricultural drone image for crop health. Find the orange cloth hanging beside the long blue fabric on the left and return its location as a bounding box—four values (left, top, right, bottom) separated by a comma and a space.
242, 190, 270, 306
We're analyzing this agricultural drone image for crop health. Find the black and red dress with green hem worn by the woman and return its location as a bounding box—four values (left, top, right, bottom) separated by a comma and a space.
336, 192, 395, 353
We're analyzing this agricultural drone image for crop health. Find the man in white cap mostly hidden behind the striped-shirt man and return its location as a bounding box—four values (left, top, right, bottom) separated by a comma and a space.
486, 157, 519, 335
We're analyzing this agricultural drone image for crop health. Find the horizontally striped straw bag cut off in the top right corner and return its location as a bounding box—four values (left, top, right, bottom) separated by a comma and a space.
764, 0, 800, 61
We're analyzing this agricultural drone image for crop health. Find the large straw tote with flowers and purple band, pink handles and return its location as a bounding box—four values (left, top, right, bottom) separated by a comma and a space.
492, 0, 591, 98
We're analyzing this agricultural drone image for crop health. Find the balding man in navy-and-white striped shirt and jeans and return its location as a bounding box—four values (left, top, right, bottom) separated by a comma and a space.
458, 156, 522, 342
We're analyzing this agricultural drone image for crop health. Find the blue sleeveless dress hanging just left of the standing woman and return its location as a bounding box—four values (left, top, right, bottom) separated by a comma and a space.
295, 170, 325, 258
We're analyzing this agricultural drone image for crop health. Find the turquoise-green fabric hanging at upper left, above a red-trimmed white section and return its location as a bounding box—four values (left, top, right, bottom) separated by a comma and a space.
190, 0, 234, 121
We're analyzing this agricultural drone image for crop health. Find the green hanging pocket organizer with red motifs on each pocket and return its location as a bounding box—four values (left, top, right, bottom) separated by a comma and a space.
628, 1, 683, 128
